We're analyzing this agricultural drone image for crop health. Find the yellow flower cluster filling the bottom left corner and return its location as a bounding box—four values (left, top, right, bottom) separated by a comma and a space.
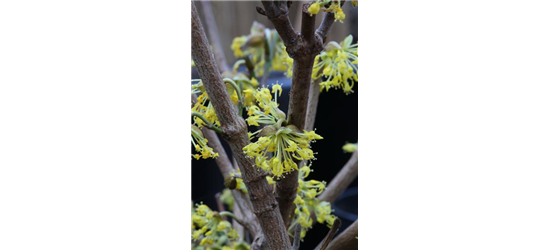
191, 202, 250, 250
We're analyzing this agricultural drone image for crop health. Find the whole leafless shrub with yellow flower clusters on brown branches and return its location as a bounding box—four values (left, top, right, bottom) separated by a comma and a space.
191, 0, 360, 250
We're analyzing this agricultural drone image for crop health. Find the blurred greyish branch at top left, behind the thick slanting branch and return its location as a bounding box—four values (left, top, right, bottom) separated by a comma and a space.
200, 0, 231, 73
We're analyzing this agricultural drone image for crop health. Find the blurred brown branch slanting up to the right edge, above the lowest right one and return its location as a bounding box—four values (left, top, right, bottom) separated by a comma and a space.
319, 150, 360, 203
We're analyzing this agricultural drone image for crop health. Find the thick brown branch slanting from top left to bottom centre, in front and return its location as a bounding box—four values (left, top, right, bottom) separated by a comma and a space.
191, 0, 291, 250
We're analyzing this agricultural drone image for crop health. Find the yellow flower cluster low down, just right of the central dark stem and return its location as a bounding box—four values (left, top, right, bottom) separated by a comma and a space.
290, 166, 336, 239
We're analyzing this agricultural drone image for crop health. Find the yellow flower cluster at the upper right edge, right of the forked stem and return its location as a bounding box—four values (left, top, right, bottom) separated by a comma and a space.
313, 36, 358, 94
